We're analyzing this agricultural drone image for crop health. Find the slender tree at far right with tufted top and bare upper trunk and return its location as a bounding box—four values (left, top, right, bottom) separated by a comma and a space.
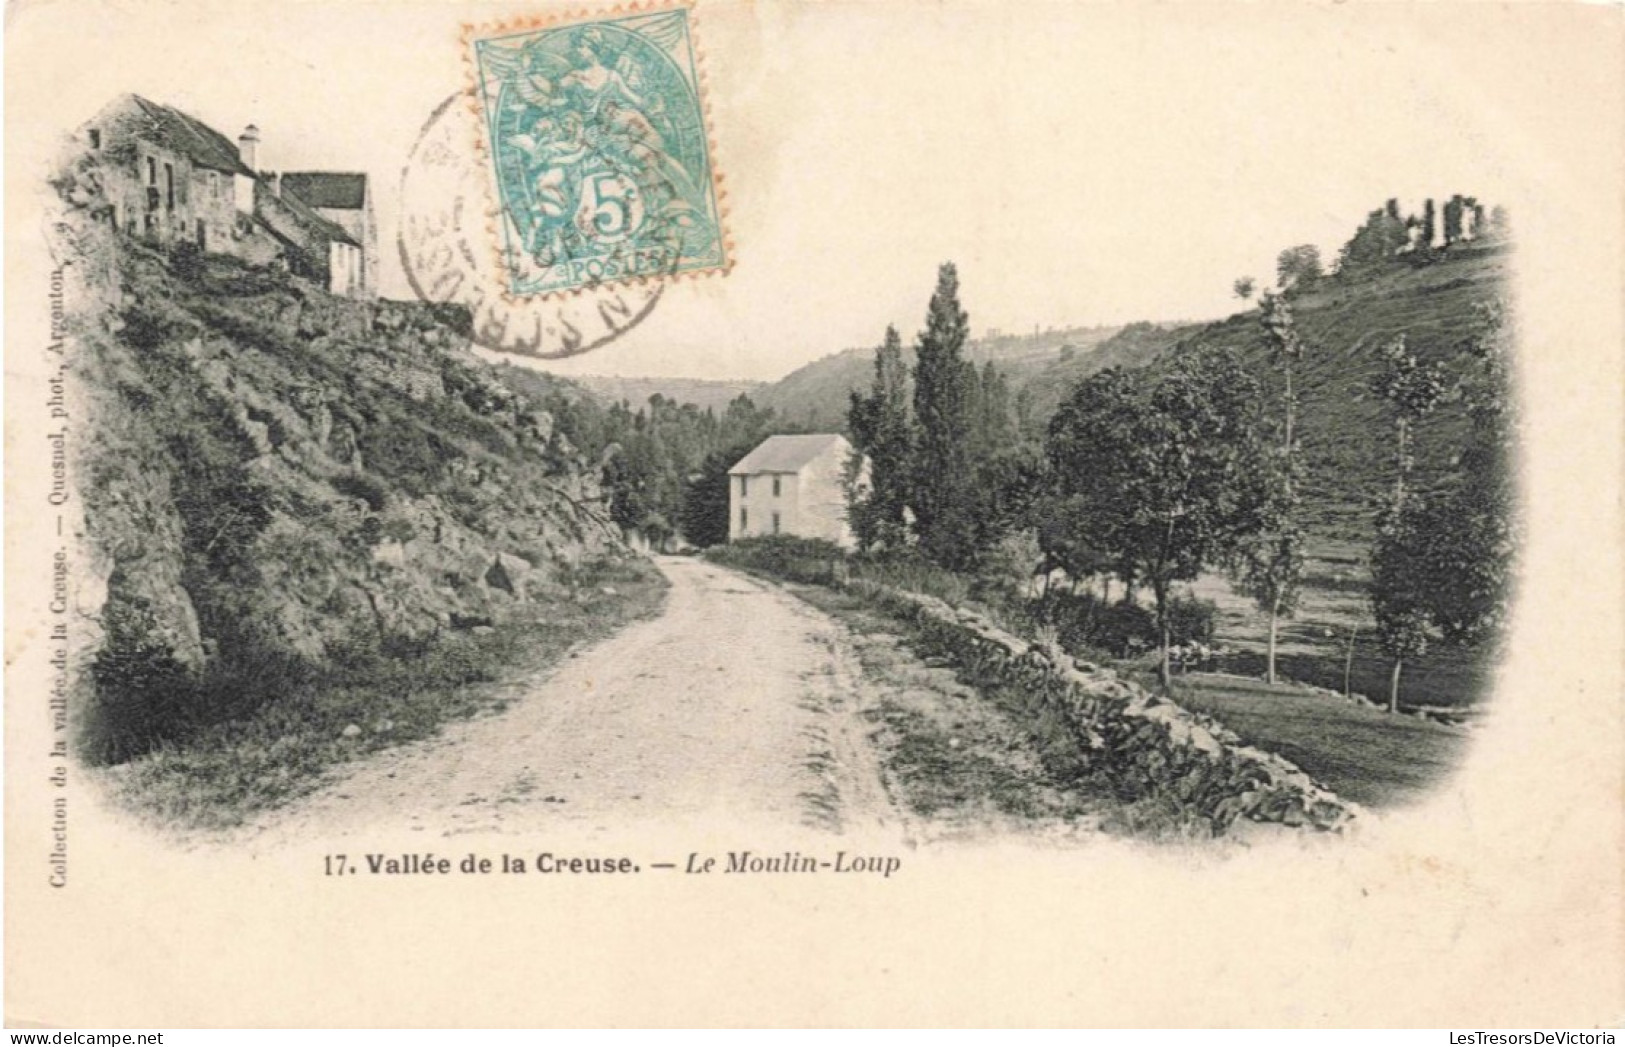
1372, 335, 1446, 712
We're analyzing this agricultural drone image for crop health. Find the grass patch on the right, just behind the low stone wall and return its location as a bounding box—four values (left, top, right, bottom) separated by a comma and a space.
1173, 673, 1472, 810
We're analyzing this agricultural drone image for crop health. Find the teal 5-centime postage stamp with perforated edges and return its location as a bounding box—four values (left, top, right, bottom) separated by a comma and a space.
465, 7, 730, 298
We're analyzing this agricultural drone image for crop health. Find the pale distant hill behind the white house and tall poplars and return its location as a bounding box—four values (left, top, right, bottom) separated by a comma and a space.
751, 327, 1120, 429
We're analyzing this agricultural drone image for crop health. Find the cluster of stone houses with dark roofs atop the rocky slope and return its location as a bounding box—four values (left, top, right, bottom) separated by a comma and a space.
78, 94, 375, 296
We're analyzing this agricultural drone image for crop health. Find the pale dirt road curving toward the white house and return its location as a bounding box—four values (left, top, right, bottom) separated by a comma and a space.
237, 558, 897, 844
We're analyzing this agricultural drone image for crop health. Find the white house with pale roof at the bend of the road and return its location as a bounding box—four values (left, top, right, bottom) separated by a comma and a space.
728, 432, 868, 548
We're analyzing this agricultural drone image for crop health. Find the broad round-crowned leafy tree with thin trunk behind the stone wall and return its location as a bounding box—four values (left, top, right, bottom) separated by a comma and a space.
1047, 348, 1268, 683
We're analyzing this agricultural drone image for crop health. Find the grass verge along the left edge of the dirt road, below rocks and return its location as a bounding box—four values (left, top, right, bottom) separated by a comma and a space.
91, 561, 668, 831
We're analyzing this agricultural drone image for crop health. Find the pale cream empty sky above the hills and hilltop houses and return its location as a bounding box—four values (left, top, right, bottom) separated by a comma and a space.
8, 0, 1610, 379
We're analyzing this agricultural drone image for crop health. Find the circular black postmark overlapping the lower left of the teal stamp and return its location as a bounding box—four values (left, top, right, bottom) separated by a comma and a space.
397, 93, 681, 359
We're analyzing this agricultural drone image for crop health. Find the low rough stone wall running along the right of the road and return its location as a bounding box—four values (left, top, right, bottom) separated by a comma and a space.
853, 582, 1359, 832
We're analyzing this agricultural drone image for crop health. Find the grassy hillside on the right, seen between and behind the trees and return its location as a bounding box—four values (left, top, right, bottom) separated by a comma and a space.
1034, 249, 1510, 706
